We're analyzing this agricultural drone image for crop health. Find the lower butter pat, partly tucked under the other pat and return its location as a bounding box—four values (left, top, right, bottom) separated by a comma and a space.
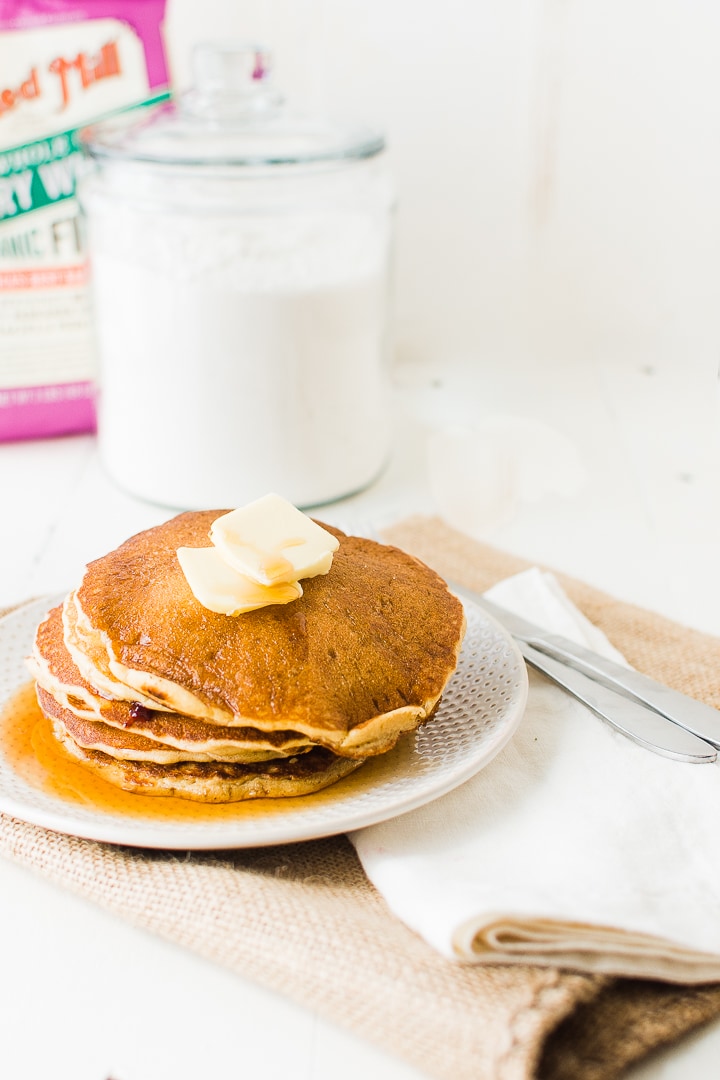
177, 548, 302, 615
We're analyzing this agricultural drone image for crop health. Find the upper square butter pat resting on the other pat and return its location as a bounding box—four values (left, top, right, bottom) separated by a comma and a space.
210, 495, 339, 587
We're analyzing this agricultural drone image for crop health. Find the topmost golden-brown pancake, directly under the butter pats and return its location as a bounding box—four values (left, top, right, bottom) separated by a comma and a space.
70, 510, 464, 758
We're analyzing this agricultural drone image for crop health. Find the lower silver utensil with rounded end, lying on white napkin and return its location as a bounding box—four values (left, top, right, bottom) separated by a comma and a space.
516, 642, 717, 765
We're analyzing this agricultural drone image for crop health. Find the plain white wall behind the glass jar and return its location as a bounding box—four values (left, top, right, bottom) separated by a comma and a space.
166, 0, 720, 380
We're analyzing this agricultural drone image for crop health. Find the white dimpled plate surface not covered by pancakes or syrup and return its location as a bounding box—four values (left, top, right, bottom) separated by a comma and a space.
0, 598, 528, 851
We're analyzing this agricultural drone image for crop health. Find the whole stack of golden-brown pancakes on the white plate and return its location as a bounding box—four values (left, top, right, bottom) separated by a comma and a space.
30, 511, 465, 802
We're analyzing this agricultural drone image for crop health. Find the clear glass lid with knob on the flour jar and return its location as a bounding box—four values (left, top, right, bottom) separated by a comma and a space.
81, 43, 385, 167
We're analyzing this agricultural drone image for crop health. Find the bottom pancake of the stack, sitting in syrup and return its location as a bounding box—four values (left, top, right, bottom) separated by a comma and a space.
49, 724, 363, 802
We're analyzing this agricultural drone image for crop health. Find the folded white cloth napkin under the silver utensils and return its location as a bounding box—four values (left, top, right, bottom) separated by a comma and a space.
351, 569, 720, 983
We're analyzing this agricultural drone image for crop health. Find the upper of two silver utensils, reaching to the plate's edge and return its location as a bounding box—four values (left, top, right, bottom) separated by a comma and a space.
449, 582, 720, 748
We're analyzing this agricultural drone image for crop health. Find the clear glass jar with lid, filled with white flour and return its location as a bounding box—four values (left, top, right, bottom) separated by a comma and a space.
79, 45, 394, 509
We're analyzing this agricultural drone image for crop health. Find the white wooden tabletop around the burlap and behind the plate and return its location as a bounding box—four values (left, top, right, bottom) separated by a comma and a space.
0, 355, 720, 1080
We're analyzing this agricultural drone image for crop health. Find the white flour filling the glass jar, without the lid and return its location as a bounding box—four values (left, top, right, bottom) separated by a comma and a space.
84, 201, 390, 508
